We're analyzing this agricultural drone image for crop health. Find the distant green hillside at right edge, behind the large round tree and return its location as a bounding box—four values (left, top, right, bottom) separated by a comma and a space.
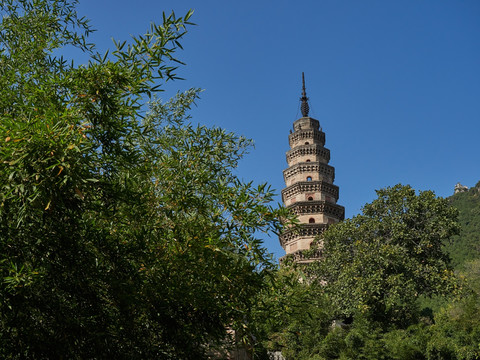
447, 181, 480, 269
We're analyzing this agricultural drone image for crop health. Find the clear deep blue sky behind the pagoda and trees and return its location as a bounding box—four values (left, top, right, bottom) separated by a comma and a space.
72, 0, 480, 257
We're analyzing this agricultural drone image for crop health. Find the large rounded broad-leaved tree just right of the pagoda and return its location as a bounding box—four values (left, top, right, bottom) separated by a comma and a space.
319, 185, 458, 328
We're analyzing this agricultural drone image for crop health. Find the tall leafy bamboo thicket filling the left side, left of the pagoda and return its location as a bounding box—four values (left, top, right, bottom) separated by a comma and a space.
0, 0, 287, 359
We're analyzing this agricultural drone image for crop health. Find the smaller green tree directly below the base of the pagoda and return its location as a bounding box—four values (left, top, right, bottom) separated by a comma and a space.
255, 265, 339, 360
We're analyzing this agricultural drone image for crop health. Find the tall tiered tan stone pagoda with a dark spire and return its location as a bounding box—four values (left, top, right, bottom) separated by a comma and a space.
279, 73, 345, 263
